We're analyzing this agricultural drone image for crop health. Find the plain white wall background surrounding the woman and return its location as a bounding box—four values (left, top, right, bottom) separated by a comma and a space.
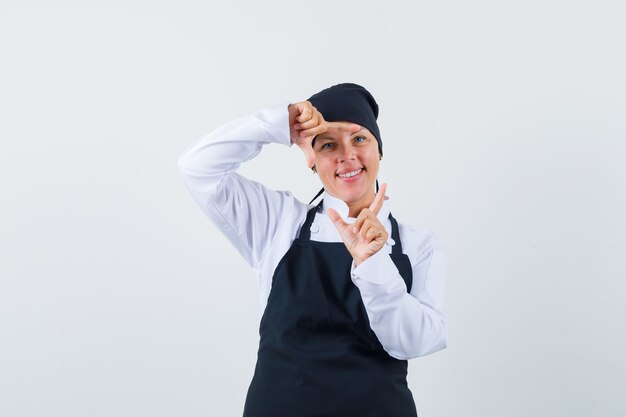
0, 0, 626, 417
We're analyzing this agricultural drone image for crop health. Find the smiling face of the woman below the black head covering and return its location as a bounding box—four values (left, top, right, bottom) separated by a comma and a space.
313, 122, 380, 206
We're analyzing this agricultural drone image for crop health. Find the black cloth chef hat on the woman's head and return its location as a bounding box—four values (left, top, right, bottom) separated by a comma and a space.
308, 83, 383, 155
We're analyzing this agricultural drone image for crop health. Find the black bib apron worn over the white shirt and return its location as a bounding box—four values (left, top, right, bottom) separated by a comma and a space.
243, 201, 417, 417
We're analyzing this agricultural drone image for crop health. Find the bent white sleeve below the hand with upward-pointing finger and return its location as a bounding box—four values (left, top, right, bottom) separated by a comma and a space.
352, 236, 448, 359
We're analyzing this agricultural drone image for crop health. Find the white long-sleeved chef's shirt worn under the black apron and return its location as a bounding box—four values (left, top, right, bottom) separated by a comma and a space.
178, 102, 448, 359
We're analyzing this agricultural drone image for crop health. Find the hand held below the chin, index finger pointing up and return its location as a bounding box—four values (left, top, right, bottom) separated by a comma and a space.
327, 183, 389, 266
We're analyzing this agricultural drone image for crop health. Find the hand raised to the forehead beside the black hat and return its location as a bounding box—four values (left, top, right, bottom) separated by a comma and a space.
289, 101, 328, 168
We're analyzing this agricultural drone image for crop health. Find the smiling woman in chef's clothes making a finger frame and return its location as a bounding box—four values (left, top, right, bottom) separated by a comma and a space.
178, 83, 447, 417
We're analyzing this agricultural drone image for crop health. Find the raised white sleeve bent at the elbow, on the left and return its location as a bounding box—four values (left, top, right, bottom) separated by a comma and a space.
178, 102, 295, 267
